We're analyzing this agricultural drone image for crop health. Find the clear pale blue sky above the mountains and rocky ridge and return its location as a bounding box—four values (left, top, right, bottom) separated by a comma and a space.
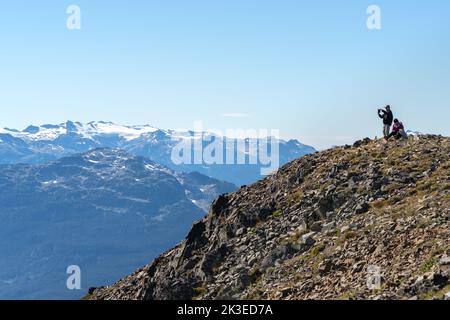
0, 0, 450, 148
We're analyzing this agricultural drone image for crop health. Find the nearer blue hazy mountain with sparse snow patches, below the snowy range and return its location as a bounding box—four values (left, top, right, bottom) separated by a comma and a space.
0, 148, 237, 299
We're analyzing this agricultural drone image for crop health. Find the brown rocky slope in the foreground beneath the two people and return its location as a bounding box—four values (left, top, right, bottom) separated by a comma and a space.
89, 135, 450, 300
